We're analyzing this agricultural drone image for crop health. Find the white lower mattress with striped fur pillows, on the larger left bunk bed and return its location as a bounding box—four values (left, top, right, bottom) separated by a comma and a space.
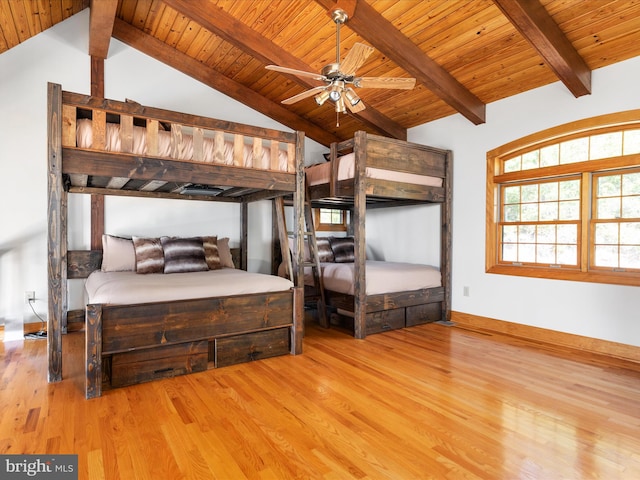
85, 268, 293, 305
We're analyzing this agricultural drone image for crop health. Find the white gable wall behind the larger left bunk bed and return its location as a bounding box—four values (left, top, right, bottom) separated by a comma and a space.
0, 9, 326, 340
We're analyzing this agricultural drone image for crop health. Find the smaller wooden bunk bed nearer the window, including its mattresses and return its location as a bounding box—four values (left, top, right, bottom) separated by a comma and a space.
306, 131, 452, 338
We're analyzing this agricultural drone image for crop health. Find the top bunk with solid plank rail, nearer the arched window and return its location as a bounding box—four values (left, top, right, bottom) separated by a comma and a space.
305, 131, 452, 208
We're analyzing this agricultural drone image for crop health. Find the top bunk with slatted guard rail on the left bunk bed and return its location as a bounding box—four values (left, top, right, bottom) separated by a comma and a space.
49, 83, 304, 202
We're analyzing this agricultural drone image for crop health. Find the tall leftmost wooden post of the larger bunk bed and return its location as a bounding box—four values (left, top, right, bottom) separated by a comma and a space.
47, 83, 67, 382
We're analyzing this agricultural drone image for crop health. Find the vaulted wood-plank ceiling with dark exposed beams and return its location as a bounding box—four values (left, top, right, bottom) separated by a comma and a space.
0, 0, 640, 145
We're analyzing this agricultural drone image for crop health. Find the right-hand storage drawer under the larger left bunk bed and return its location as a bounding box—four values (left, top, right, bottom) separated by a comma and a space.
215, 328, 291, 368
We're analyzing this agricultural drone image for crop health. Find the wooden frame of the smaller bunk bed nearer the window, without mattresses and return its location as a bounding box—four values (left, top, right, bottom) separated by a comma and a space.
307, 131, 453, 338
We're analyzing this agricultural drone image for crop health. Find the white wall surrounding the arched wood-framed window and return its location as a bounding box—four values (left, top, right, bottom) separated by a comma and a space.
409, 57, 640, 346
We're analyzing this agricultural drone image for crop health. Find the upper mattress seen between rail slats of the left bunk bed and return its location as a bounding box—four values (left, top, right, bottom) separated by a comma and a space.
76, 119, 288, 172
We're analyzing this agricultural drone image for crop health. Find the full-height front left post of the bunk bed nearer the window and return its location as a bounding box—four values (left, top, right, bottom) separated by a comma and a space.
353, 131, 367, 338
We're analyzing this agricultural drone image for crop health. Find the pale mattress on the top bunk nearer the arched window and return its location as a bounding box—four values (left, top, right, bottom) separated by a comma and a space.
305, 153, 442, 187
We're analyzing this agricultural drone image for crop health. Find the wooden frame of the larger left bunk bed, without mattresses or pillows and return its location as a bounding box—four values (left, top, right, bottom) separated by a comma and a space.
47, 83, 304, 398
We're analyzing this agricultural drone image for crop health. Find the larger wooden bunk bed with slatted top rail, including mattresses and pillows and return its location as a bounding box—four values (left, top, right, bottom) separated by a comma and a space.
47, 83, 304, 398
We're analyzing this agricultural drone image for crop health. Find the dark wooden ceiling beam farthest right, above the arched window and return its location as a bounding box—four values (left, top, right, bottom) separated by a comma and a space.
493, 0, 591, 97
